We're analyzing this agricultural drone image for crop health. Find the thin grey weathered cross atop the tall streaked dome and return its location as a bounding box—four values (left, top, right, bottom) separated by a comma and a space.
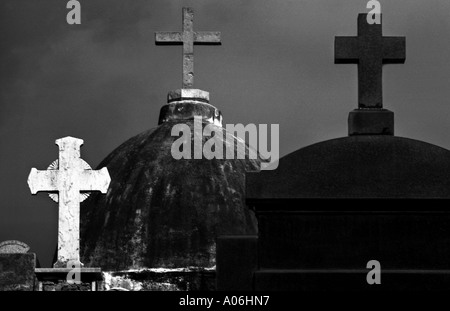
155, 8, 220, 89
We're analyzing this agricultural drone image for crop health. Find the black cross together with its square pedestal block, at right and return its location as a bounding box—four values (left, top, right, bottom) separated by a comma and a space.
335, 14, 406, 135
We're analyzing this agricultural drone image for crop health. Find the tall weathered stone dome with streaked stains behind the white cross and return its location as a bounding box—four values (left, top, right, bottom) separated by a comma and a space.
81, 121, 259, 270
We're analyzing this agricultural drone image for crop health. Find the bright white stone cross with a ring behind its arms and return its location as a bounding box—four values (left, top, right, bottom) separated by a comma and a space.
28, 137, 111, 268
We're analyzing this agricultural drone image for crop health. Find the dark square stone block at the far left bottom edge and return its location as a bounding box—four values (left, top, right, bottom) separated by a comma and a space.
0, 253, 36, 291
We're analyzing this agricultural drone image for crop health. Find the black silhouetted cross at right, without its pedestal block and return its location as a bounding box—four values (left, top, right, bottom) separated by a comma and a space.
334, 14, 406, 108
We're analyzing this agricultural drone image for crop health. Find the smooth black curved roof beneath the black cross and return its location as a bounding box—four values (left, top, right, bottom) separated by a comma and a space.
246, 135, 450, 202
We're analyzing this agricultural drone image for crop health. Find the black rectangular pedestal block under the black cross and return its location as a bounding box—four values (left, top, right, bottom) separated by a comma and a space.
348, 109, 394, 136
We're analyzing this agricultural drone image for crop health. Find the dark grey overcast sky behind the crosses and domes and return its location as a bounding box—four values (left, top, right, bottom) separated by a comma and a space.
0, 0, 450, 266
